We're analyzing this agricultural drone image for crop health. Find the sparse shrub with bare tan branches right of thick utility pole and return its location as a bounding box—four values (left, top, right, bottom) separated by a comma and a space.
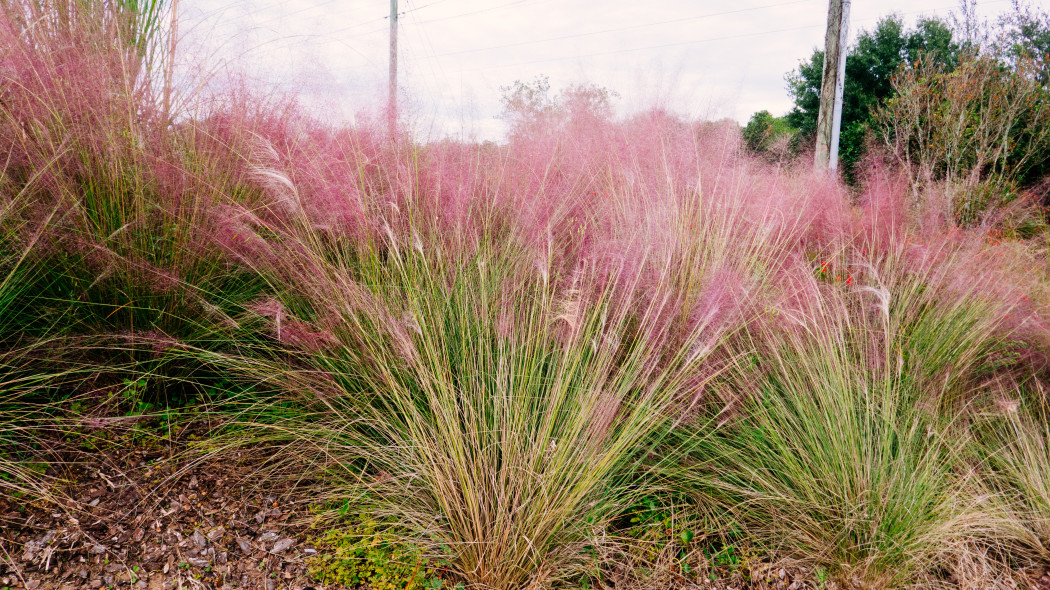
875, 55, 1050, 226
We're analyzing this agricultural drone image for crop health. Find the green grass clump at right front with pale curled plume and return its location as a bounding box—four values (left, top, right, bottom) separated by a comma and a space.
667, 196, 1037, 588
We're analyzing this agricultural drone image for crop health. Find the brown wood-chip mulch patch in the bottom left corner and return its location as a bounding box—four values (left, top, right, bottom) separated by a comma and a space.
0, 425, 336, 590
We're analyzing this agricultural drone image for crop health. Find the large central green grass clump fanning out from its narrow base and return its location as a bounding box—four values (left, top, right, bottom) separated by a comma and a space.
212, 197, 718, 588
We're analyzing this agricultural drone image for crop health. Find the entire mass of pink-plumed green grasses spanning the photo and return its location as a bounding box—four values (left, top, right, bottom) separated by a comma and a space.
6, 1, 1050, 589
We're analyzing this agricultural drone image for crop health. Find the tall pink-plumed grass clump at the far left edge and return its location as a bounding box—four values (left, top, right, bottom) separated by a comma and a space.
0, 1, 283, 383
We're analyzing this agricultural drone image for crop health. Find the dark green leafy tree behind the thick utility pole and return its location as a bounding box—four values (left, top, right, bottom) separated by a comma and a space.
786, 15, 962, 178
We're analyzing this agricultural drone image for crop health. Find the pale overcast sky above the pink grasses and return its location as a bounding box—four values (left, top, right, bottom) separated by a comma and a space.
179, 0, 1024, 139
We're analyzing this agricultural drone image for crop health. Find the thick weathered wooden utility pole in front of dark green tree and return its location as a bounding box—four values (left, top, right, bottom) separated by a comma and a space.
814, 0, 849, 171
